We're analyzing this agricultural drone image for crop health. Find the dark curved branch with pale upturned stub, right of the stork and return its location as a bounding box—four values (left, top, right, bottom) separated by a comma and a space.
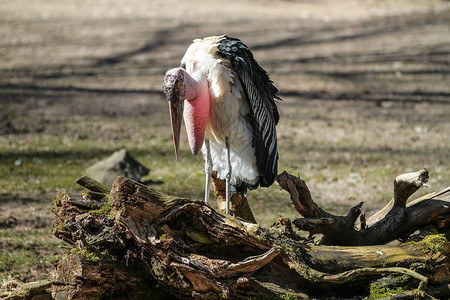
277, 169, 450, 245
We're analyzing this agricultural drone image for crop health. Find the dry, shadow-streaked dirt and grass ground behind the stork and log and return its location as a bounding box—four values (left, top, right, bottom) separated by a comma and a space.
0, 0, 450, 281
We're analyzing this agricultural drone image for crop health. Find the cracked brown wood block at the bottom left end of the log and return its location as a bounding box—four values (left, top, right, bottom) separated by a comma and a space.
51, 251, 167, 300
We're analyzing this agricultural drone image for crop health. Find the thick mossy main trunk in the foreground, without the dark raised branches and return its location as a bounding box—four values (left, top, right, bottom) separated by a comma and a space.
46, 172, 450, 299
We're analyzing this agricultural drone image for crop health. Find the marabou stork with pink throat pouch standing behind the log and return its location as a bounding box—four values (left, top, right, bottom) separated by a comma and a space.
163, 35, 280, 214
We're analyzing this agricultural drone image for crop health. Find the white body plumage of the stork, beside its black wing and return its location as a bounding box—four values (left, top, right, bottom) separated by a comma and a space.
182, 37, 259, 186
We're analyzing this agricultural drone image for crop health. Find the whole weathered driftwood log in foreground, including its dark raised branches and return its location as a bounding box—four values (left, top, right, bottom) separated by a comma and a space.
42, 170, 450, 299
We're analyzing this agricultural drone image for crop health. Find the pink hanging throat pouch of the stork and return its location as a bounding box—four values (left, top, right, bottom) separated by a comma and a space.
183, 74, 211, 155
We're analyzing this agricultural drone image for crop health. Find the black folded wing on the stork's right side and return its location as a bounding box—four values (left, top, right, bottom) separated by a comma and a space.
218, 36, 280, 188
